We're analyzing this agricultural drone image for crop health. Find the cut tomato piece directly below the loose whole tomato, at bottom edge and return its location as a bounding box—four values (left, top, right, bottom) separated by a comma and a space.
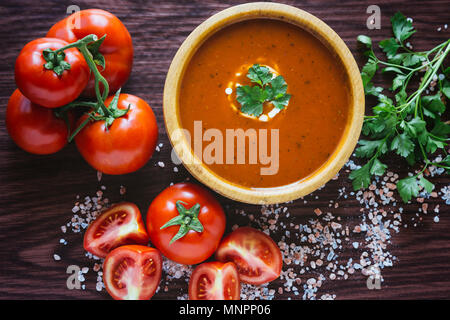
189, 261, 241, 300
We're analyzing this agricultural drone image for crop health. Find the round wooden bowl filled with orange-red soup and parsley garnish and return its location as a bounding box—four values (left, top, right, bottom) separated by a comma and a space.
163, 2, 364, 204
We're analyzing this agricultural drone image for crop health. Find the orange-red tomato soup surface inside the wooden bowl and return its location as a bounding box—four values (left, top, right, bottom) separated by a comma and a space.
178, 19, 351, 188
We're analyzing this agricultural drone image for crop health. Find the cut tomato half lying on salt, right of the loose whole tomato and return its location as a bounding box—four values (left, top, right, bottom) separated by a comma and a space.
216, 227, 283, 285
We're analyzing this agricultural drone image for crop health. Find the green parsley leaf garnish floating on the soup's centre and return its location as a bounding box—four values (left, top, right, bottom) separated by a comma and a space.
236, 64, 291, 117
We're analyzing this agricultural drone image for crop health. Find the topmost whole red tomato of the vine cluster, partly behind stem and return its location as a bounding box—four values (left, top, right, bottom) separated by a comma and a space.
47, 9, 133, 97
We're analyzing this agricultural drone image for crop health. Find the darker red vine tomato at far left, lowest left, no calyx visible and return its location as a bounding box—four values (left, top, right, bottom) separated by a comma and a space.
6, 89, 68, 154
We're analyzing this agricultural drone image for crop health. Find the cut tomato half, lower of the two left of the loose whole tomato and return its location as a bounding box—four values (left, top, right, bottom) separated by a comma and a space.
103, 245, 162, 300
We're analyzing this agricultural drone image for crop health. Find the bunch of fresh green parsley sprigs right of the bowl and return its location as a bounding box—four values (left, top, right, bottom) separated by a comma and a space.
350, 12, 450, 202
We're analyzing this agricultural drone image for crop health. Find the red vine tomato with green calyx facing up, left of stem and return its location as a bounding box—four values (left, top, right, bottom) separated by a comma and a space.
15, 38, 90, 108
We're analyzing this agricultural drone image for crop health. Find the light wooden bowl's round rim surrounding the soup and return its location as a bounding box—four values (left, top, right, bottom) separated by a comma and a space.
163, 2, 364, 204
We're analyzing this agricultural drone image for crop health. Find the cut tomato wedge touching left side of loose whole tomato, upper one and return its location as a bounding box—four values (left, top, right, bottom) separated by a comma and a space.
84, 202, 148, 258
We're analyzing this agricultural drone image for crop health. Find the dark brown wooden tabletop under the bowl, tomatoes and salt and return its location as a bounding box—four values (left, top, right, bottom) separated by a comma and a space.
0, 0, 450, 299
